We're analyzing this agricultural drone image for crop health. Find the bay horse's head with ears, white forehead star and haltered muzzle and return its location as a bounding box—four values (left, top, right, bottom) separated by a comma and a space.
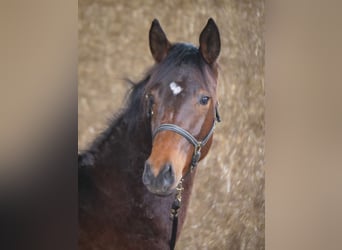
142, 18, 220, 195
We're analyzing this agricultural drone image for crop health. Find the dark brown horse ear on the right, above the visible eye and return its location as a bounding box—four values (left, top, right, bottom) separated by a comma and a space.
199, 18, 221, 64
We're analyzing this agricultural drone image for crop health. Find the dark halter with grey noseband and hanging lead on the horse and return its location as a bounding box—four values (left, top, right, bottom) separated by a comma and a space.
151, 105, 221, 250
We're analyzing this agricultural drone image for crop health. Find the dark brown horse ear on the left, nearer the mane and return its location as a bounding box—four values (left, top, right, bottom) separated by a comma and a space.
149, 19, 171, 63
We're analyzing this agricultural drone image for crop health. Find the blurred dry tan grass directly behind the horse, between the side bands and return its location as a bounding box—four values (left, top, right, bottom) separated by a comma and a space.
78, 0, 265, 250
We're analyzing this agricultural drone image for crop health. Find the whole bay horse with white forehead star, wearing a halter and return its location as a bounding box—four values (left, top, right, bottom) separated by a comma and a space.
78, 18, 221, 250
